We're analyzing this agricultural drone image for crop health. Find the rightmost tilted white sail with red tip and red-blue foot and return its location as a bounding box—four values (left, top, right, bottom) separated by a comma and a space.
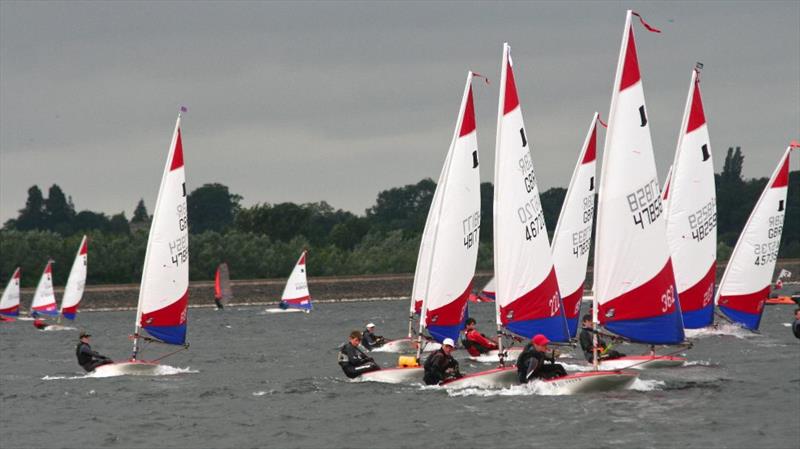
714, 146, 792, 330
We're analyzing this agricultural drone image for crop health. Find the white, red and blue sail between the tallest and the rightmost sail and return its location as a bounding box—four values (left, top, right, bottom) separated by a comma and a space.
665, 70, 717, 329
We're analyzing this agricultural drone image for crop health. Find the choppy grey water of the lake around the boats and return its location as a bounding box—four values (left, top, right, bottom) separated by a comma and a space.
0, 301, 800, 449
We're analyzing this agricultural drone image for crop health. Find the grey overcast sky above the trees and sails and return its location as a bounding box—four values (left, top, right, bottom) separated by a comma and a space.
0, 0, 800, 221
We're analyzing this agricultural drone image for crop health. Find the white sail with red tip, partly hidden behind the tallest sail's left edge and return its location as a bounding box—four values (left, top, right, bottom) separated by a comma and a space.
553, 112, 598, 337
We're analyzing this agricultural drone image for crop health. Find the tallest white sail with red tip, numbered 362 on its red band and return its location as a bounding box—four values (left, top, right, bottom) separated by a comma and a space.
594, 11, 684, 344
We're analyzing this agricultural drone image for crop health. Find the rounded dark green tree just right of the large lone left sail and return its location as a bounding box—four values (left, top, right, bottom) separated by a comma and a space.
189, 183, 242, 234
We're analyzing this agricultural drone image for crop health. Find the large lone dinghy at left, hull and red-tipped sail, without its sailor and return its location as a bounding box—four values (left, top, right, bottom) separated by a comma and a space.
94, 108, 189, 377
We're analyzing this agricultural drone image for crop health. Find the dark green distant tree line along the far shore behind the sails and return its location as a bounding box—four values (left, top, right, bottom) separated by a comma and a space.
0, 147, 800, 288
